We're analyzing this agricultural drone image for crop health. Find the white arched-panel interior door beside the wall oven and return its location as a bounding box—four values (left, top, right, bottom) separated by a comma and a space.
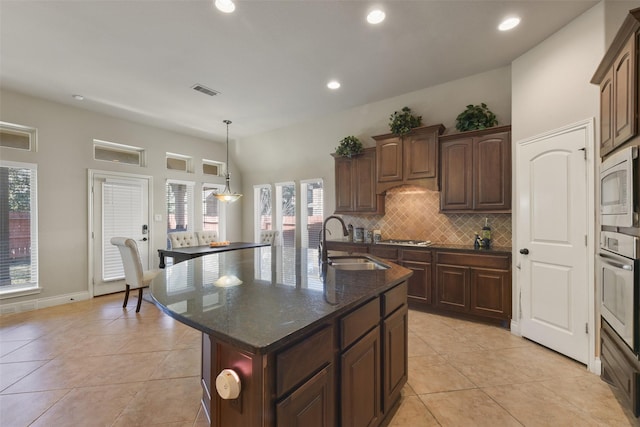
516, 123, 593, 364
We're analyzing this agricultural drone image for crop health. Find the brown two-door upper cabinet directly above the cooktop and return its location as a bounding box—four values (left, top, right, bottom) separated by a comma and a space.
373, 124, 444, 194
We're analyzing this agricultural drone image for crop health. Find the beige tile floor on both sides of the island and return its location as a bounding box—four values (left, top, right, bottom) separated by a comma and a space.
0, 294, 640, 427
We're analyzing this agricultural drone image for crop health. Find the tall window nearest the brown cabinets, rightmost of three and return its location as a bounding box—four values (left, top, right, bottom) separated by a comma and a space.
300, 179, 324, 249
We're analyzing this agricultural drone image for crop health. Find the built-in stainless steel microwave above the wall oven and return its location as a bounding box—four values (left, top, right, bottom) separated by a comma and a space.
600, 147, 640, 227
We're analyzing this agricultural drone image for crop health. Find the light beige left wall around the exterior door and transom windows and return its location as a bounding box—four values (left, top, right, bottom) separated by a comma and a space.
0, 91, 242, 311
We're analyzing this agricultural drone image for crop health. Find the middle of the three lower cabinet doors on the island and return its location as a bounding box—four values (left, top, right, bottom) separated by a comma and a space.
341, 326, 382, 427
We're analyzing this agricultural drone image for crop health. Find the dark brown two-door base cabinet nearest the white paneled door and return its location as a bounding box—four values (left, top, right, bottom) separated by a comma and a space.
434, 251, 511, 322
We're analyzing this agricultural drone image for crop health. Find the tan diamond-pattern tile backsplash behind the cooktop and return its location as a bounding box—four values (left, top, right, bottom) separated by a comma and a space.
342, 186, 511, 246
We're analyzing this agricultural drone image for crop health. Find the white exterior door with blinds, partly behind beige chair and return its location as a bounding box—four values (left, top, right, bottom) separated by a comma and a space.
89, 172, 150, 295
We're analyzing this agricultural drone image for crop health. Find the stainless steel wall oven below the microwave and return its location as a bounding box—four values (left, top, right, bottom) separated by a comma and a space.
598, 231, 640, 357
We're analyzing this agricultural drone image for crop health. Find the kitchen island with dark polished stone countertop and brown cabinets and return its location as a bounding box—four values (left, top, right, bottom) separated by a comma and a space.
150, 247, 412, 427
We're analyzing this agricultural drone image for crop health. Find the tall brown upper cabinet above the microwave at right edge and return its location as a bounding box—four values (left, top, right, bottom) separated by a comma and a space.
591, 8, 640, 157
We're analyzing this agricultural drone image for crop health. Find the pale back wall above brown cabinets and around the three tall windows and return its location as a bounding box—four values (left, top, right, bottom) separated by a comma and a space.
238, 66, 511, 239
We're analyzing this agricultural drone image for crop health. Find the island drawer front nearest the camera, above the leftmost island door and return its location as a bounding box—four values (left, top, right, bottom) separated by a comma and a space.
276, 326, 334, 398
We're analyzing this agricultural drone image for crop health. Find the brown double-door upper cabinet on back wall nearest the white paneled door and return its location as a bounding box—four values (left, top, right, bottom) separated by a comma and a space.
440, 126, 511, 212
